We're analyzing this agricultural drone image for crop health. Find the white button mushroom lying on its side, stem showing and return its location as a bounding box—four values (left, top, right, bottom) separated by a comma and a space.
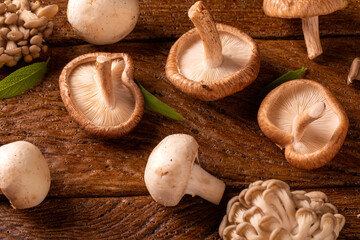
144, 134, 225, 206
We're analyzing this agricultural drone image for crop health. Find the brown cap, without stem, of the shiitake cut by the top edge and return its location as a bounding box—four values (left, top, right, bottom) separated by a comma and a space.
263, 0, 348, 18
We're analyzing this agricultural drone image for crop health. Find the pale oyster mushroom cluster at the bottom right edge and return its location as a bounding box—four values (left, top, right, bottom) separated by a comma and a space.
219, 179, 345, 240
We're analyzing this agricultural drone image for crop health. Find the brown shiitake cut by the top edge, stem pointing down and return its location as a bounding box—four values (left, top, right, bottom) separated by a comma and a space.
263, 0, 348, 59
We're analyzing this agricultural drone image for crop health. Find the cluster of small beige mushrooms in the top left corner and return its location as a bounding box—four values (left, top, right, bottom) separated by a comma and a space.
0, 0, 59, 68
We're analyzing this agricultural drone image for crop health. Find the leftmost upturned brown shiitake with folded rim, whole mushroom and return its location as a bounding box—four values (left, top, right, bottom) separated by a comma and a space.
59, 52, 144, 138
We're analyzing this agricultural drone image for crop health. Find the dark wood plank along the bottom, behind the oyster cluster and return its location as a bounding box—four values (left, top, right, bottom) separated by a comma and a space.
0, 186, 360, 240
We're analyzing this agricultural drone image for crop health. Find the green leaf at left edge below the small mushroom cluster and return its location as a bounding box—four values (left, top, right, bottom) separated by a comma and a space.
0, 59, 49, 99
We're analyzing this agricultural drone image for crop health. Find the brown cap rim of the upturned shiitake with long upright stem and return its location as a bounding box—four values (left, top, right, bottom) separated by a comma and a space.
165, 23, 260, 101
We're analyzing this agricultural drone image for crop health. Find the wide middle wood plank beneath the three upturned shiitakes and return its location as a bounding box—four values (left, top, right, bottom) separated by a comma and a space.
0, 38, 360, 197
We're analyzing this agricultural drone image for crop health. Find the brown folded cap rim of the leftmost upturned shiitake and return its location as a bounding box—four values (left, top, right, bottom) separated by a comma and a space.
59, 52, 144, 138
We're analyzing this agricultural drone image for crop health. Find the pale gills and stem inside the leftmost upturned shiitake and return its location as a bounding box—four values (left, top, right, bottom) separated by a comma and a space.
69, 56, 135, 126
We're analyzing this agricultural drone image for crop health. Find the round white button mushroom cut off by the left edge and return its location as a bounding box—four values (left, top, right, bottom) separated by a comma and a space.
0, 141, 50, 209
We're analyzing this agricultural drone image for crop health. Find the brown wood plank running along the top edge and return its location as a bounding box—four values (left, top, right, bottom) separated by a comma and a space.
48, 0, 360, 45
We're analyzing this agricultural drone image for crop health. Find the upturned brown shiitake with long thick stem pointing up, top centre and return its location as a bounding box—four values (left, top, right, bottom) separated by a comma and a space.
165, 1, 260, 101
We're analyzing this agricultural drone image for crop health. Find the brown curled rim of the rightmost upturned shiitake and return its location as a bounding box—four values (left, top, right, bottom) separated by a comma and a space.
258, 79, 349, 170
